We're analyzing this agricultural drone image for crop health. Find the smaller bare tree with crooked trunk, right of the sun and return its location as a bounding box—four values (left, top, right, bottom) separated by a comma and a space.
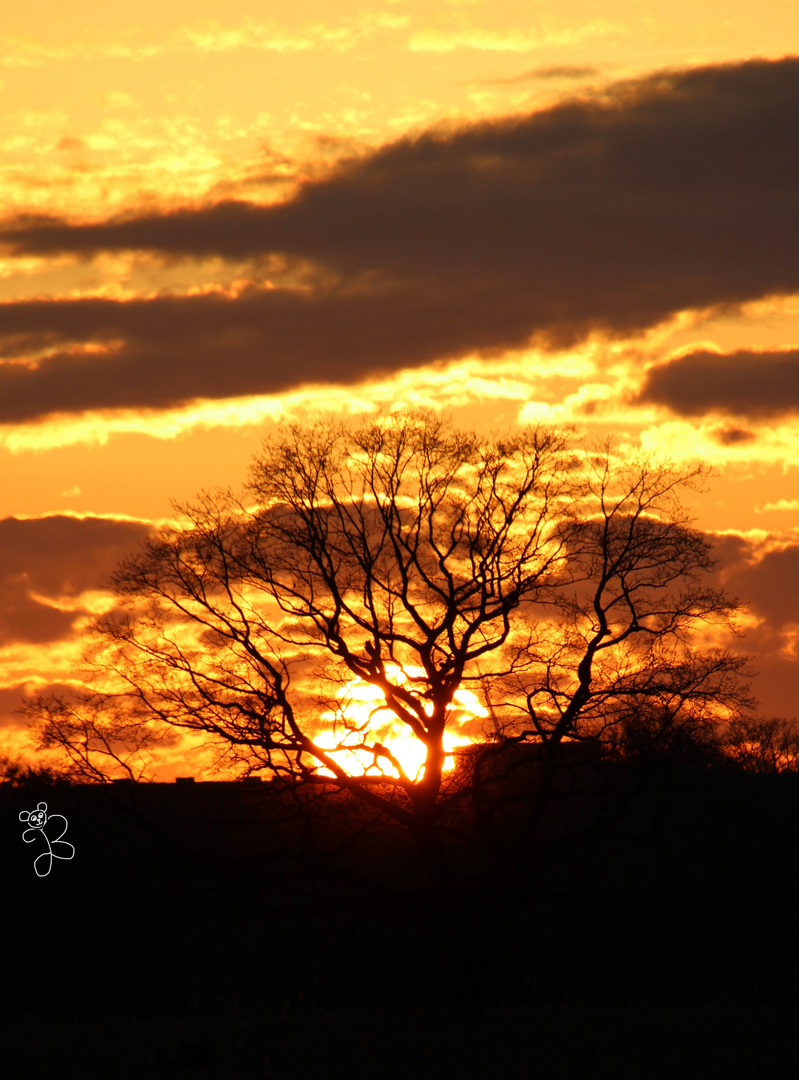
464, 451, 754, 829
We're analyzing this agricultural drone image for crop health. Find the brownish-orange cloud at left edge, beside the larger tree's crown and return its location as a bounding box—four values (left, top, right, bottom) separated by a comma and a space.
0, 515, 149, 647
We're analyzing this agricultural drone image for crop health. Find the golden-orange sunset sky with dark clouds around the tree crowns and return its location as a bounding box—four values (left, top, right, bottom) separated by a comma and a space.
0, 0, 799, 772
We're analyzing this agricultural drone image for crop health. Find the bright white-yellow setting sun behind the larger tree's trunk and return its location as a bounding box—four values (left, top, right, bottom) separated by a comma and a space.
314, 665, 488, 780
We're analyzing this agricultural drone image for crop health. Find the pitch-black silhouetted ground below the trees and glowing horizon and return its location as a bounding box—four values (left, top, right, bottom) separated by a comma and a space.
0, 773, 799, 1080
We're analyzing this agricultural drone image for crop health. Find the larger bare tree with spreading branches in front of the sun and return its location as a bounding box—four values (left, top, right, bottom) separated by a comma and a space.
79, 414, 574, 865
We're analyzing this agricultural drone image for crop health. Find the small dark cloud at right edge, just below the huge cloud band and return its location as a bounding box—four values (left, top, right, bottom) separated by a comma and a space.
638, 349, 799, 416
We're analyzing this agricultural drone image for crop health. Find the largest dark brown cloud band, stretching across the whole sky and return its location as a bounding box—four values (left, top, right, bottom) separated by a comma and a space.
0, 58, 799, 421
